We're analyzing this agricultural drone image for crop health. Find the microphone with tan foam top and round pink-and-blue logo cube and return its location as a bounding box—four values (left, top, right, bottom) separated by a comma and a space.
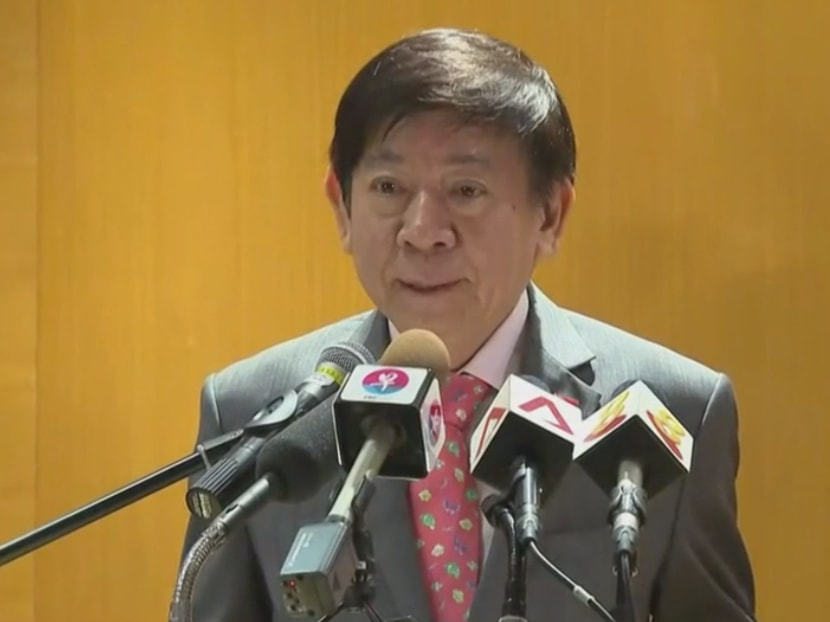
280, 330, 449, 619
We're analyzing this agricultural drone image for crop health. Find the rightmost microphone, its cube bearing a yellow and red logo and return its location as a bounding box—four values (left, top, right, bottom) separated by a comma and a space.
573, 380, 693, 574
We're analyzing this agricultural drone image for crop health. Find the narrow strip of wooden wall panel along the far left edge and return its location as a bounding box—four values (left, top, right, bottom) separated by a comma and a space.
0, 0, 37, 622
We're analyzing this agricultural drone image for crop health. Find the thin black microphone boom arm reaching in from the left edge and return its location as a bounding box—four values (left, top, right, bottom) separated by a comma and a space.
0, 430, 243, 566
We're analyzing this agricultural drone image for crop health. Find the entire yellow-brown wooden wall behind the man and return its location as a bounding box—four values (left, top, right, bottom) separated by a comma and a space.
0, 0, 830, 622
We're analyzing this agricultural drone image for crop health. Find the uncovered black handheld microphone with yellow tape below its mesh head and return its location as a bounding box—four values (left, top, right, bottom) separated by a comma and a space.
185, 343, 374, 519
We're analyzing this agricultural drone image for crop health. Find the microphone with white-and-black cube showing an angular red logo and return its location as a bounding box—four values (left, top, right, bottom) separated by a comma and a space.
470, 375, 582, 545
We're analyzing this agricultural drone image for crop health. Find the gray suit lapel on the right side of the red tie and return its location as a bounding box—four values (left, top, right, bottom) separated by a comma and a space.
470, 284, 600, 622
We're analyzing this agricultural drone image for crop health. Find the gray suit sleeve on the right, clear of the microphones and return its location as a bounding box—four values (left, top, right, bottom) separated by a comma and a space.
652, 374, 755, 622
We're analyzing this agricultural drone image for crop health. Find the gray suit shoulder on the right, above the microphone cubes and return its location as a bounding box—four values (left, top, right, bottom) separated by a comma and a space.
565, 310, 728, 401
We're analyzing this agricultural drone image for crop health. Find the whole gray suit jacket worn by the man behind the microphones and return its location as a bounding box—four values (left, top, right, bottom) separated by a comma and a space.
179, 284, 755, 622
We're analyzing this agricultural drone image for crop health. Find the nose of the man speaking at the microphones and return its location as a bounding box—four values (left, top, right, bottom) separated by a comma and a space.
398, 190, 456, 251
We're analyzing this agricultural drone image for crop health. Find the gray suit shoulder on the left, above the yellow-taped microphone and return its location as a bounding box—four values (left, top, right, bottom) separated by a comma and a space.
203, 311, 370, 426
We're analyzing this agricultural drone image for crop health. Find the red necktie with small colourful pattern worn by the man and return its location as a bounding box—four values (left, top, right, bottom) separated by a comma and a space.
409, 374, 490, 622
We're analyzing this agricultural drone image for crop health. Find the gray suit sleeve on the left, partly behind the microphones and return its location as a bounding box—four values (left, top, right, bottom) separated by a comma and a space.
176, 376, 272, 622
